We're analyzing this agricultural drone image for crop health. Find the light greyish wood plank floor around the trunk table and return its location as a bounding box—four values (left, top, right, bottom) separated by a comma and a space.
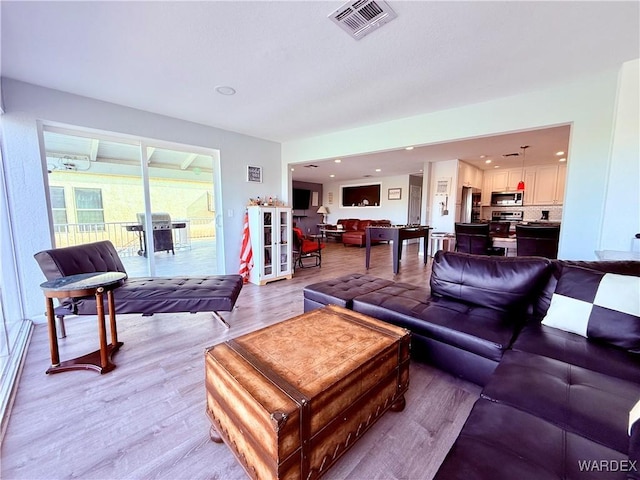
0, 243, 480, 480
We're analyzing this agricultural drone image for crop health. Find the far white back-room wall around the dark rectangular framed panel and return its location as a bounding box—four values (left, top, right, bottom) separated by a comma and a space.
323, 175, 409, 225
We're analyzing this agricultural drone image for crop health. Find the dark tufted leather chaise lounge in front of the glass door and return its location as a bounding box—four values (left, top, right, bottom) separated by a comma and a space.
34, 240, 243, 330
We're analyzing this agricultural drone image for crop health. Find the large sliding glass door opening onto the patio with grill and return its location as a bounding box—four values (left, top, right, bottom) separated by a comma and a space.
44, 127, 218, 276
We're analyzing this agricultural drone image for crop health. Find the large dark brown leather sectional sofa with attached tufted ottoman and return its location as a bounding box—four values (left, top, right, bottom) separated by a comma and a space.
304, 251, 640, 480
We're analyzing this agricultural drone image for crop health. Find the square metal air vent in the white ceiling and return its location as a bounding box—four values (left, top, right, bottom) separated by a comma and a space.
329, 0, 397, 40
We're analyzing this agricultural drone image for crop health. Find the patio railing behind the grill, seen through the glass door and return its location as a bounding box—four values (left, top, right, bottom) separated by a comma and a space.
54, 218, 215, 257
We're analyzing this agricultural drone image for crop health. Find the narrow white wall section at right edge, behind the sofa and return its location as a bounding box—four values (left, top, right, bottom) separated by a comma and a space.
600, 60, 640, 251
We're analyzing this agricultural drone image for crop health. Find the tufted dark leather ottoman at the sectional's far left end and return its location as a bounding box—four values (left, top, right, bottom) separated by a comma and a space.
304, 273, 393, 312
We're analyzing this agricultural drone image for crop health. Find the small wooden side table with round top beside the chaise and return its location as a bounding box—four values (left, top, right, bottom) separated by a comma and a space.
40, 272, 127, 373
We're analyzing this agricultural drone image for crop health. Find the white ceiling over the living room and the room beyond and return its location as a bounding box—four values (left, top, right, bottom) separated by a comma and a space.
0, 0, 640, 184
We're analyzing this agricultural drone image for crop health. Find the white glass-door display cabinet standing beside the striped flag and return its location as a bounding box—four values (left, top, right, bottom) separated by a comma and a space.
248, 206, 293, 285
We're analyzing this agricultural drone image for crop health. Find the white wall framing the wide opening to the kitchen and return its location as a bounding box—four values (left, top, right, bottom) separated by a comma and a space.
282, 65, 637, 259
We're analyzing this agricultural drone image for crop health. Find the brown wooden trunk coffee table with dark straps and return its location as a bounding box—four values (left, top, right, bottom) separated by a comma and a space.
205, 306, 409, 479
